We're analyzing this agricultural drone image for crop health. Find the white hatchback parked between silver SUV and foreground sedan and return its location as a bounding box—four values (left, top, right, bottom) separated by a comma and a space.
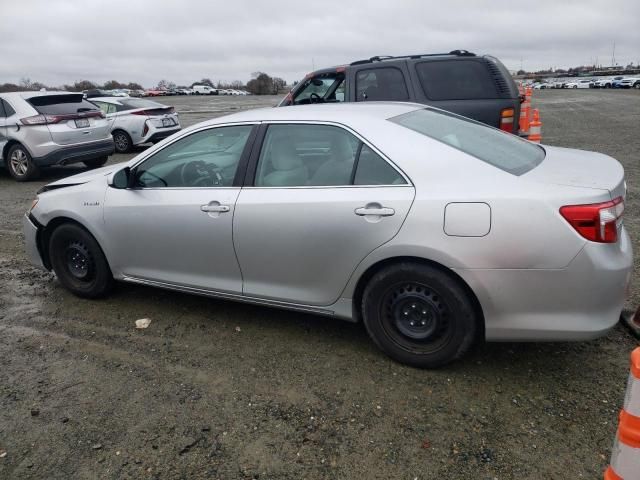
91, 97, 181, 153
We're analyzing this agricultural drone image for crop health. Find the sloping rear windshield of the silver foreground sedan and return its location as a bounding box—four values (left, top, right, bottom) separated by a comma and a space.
389, 109, 545, 175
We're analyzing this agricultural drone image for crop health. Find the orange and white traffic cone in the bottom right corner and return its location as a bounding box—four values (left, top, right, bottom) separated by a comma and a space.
604, 347, 640, 480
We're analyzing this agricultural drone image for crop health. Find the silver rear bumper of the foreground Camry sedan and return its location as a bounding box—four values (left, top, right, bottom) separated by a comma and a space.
456, 229, 633, 341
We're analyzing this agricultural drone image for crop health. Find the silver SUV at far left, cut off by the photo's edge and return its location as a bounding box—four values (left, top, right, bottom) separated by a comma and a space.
0, 91, 113, 182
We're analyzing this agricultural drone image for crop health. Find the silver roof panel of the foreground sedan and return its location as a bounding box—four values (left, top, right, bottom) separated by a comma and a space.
200, 102, 426, 125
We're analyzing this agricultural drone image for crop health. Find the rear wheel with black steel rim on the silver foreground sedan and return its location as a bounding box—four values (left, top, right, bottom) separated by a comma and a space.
362, 262, 479, 368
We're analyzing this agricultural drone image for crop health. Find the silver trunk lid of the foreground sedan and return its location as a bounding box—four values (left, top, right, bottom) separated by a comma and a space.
522, 145, 625, 198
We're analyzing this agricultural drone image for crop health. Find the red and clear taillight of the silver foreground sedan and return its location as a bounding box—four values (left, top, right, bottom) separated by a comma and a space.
560, 197, 624, 243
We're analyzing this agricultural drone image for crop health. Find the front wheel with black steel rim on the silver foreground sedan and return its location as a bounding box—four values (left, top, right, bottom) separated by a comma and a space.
49, 223, 113, 298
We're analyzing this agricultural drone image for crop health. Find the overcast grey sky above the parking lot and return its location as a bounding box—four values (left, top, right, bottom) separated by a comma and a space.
0, 0, 640, 87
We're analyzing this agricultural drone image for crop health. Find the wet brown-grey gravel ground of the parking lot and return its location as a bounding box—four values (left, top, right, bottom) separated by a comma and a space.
0, 90, 640, 480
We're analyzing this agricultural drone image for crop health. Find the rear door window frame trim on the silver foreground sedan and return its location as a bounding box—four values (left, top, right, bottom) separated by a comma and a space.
243, 120, 413, 189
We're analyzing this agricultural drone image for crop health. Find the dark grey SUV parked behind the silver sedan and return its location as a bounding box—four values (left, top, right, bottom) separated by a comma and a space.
278, 50, 522, 133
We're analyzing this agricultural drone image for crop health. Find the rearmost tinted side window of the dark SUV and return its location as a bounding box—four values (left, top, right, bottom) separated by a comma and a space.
416, 60, 500, 100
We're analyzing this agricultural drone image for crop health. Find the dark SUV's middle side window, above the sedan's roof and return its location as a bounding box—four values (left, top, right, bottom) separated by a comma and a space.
356, 67, 409, 102
